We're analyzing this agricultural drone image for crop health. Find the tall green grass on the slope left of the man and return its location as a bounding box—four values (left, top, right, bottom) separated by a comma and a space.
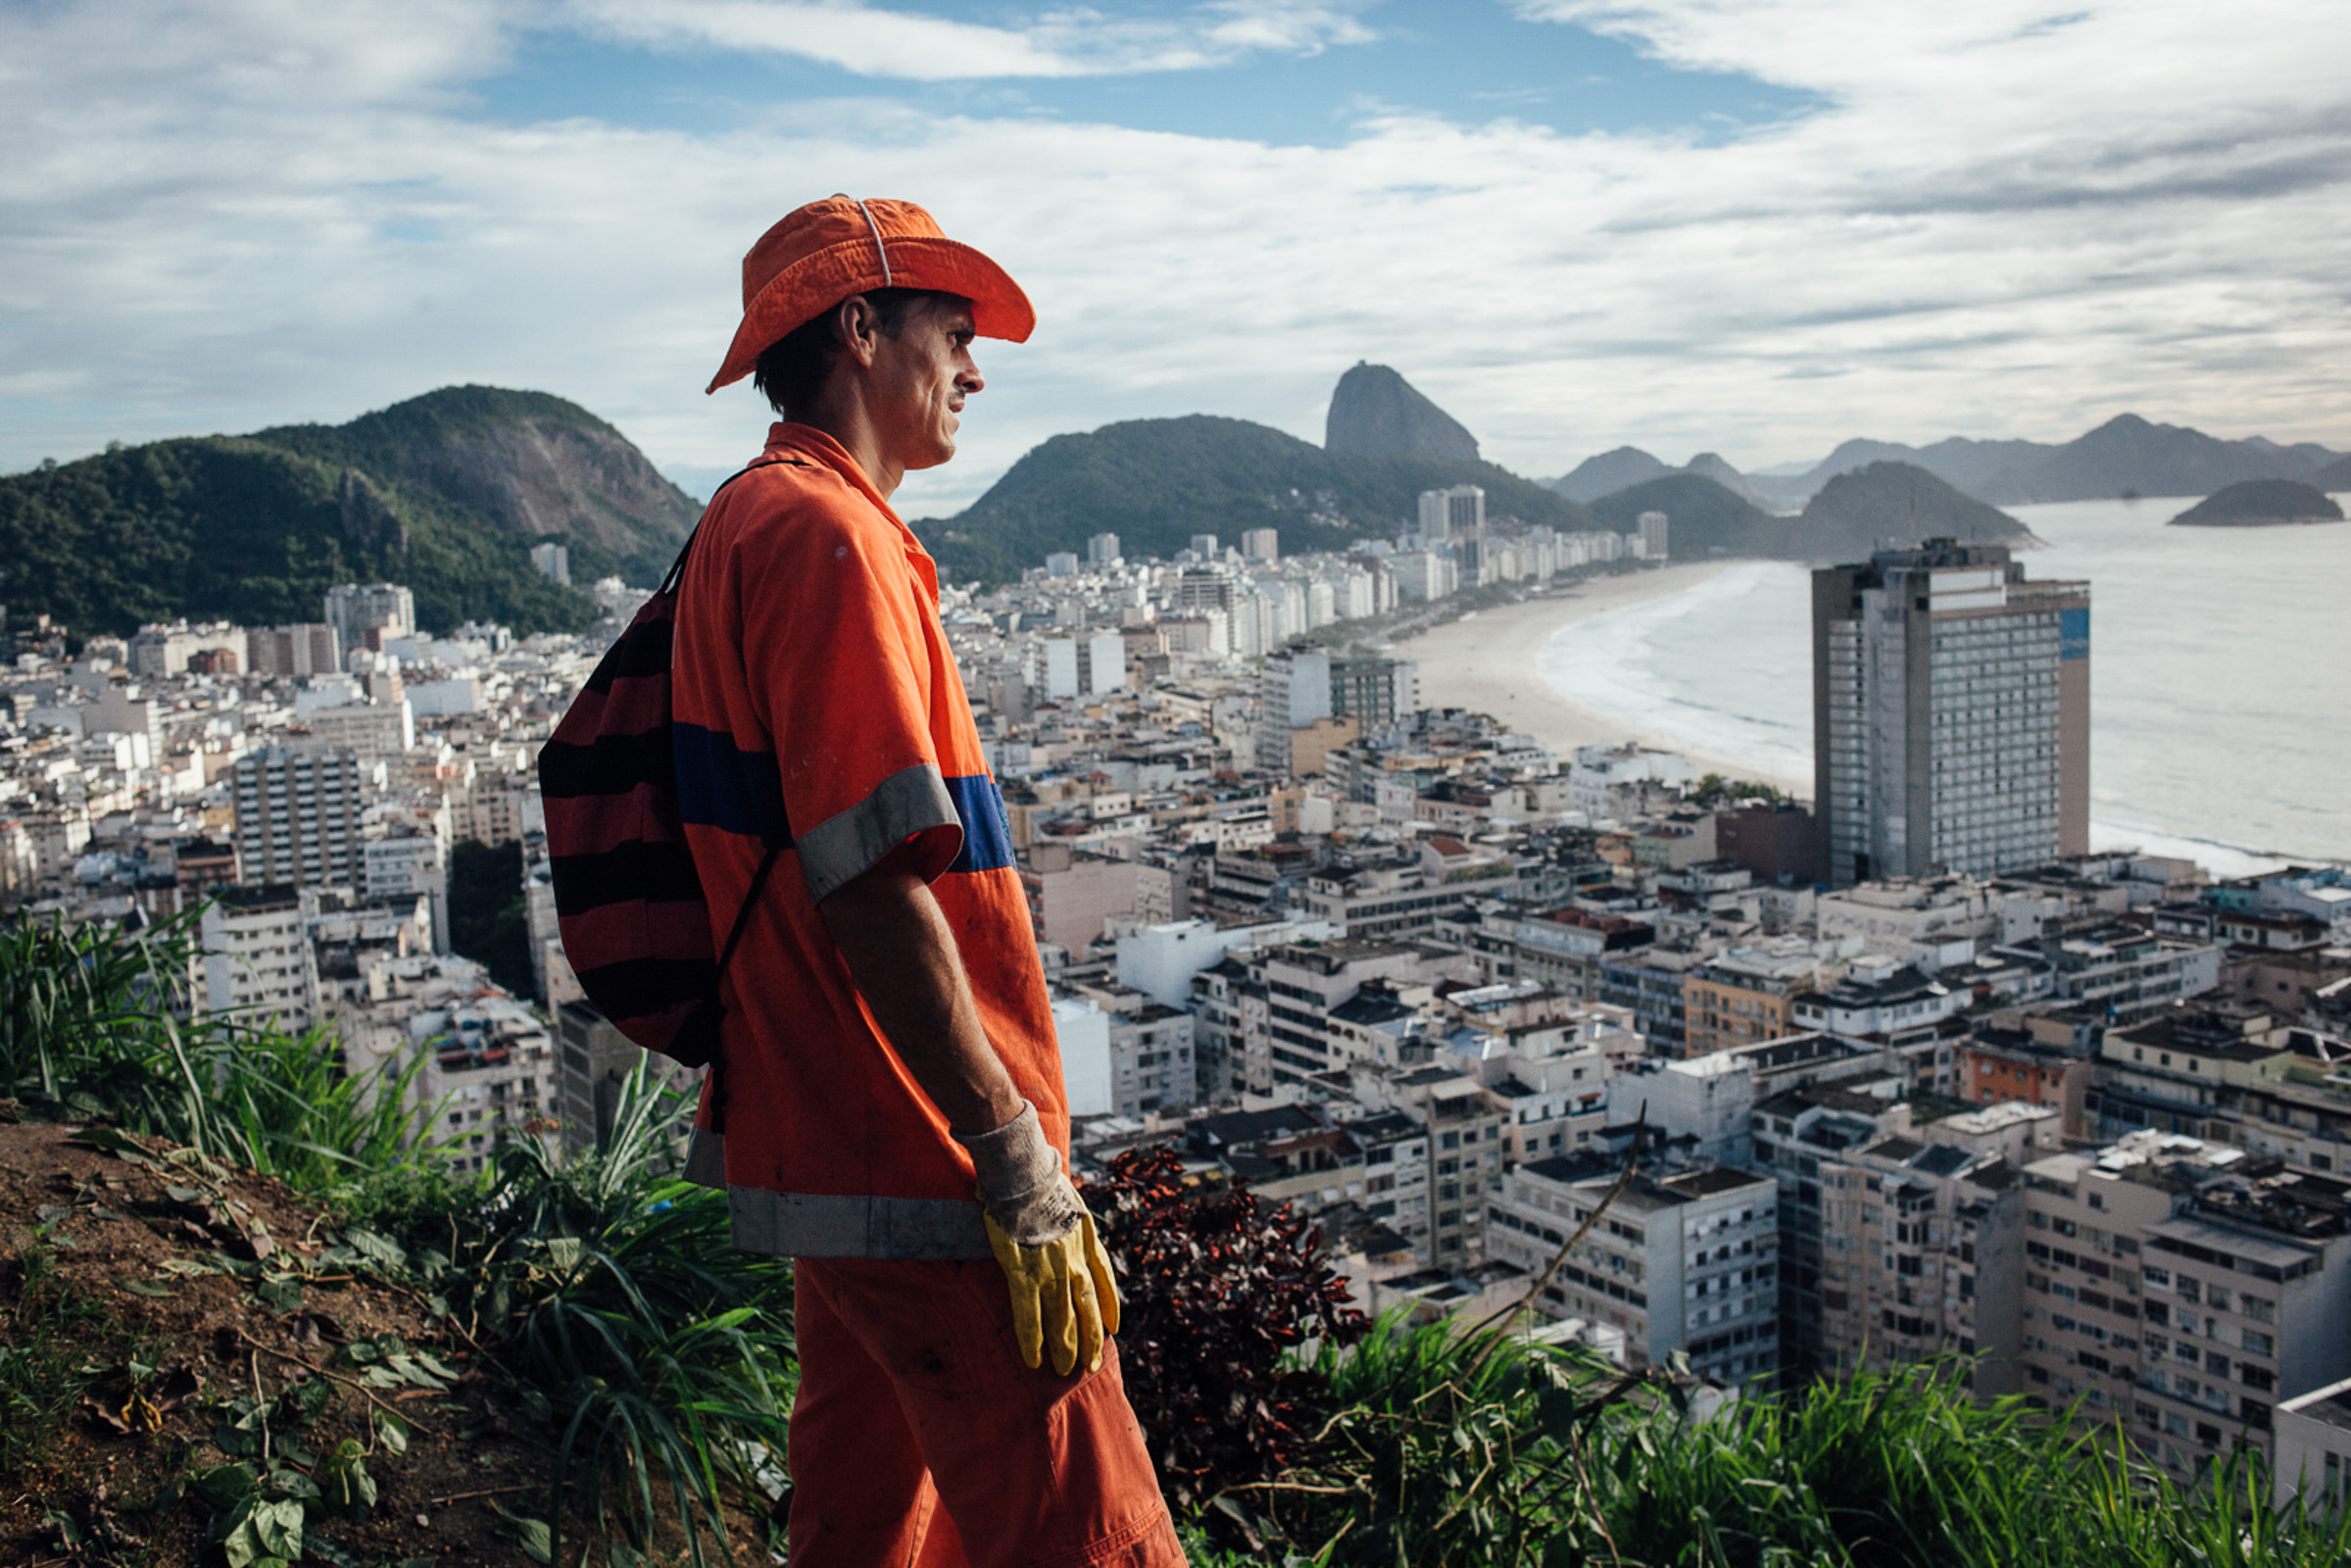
0, 914, 795, 1563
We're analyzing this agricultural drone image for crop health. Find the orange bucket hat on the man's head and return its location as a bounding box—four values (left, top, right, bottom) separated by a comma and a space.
703, 195, 1037, 393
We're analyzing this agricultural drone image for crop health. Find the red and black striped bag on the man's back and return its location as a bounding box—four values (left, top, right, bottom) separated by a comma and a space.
538, 459, 790, 1067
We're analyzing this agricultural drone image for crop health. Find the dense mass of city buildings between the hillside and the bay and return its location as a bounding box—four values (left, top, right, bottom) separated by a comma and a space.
0, 487, 2351, 1491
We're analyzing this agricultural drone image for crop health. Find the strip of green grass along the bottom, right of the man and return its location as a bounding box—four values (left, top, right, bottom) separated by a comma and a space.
1201, 1328, 2351, 1568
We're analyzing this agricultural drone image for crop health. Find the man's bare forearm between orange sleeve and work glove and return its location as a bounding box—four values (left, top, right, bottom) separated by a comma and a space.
818, 854, 1023, 1136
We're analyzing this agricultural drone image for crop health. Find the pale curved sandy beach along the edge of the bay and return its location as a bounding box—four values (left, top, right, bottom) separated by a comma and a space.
1396, 562, 1810, 795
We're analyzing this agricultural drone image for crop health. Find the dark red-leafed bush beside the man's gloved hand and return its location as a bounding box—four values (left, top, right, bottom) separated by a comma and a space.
1086, 1148, 1368, 1504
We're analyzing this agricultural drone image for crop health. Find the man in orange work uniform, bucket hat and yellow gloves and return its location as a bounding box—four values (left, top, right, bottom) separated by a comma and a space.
672, 195, 1183, 1568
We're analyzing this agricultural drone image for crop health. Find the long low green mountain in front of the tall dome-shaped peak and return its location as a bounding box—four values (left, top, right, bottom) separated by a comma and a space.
912, 414, 1594, 583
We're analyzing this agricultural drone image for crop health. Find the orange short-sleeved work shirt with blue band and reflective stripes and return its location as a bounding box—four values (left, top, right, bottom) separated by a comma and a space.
672, 423, 1070, 1257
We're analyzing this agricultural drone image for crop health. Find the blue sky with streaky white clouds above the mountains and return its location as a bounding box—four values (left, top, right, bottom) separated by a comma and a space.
0, 0, 2351, 514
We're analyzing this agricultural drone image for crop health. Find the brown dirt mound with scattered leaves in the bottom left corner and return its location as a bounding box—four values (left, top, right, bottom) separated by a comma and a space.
0, 1124, 766, 1568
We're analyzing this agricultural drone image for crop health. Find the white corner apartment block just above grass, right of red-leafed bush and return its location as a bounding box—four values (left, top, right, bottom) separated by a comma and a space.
1486, 1154, 1780, 1382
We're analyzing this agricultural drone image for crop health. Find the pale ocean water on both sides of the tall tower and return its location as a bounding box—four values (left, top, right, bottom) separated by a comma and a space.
1538, 499, 2351, 874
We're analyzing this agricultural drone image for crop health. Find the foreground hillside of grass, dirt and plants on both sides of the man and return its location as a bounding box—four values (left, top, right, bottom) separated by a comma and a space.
0, 917, 2351, 1568
